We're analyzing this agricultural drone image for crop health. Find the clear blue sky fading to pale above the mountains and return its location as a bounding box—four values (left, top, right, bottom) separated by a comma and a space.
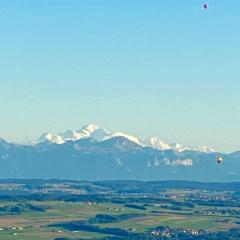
0, 0, 240, 151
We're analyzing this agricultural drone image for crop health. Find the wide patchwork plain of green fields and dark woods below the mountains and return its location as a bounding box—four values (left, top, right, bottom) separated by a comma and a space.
0, 180, 240, 240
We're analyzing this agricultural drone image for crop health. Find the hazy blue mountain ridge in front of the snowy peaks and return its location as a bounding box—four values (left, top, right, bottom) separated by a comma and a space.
0, 124, 240, 182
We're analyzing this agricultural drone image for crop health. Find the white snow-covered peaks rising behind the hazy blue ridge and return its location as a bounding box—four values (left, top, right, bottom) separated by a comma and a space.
37, 123, 215, 153
